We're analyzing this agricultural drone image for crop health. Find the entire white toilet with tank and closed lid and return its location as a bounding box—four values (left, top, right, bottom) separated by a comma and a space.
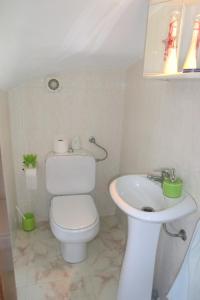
46, 153, 99, 263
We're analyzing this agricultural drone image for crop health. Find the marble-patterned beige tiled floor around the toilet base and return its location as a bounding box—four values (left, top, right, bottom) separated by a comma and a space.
13, 217, 125, 300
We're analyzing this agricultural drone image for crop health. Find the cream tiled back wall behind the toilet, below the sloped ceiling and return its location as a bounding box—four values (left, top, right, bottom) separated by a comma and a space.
9, 71, 125, 219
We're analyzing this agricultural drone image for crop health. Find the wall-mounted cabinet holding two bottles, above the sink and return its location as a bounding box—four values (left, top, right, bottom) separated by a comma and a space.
144, 0, 200, 79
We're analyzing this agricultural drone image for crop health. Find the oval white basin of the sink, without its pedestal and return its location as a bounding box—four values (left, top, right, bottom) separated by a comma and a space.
110, 175, 196, 223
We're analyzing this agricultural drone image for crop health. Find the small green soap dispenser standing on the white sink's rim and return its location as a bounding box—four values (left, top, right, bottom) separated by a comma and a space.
162, 169, 183, 198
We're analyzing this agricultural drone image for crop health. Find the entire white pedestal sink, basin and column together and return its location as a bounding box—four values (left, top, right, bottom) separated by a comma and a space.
110, 175, 196, 300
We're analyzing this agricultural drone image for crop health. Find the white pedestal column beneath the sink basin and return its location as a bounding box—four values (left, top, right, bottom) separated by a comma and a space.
117, 216, 161, 300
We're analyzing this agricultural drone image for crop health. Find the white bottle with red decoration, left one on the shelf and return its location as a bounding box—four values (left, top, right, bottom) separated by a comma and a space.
163, 11, 178, 74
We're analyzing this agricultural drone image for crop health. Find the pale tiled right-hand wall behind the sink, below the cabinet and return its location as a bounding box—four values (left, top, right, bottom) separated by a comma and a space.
121, 63, 200, 295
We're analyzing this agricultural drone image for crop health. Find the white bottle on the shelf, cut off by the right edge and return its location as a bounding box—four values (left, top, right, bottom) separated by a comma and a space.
183, 15, 200, 72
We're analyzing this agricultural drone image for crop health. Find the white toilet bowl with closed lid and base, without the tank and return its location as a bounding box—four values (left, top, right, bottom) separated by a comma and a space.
50, 195, 99, 263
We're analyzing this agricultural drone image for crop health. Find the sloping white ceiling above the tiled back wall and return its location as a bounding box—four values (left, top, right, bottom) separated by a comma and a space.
0, 0, 148, 89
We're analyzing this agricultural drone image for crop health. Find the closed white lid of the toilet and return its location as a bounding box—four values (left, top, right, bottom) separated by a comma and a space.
51, 195, 98, 230
